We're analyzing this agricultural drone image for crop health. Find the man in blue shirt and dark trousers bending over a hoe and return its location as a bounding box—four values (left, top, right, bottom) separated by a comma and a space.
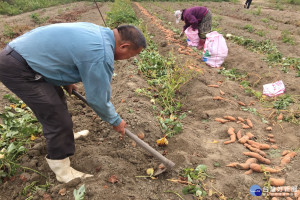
0, 22, 146, 183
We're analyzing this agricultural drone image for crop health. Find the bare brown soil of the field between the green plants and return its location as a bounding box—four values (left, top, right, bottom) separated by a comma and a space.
0, 1, 300, 200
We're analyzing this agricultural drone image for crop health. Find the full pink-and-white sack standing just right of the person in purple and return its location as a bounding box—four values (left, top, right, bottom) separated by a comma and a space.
202, 31, 228, 67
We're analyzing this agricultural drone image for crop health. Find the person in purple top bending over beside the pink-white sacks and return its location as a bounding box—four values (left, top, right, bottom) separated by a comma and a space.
175, 6, 212, 49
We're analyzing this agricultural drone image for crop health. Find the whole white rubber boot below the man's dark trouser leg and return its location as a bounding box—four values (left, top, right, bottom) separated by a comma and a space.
46, 157, 93, 183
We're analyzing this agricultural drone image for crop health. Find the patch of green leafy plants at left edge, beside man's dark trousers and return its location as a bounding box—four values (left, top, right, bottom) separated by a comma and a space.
0, 95, 42, 182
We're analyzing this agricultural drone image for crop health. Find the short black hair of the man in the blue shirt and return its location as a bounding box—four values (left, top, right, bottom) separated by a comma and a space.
117, 25, 147, 49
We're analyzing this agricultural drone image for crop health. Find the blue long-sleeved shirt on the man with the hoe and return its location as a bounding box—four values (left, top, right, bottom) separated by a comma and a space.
9, 22, 122, 126
